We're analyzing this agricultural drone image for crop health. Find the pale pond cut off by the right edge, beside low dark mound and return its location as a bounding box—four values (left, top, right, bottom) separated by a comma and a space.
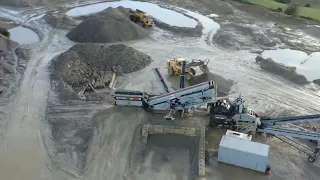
262, 49, 320, 81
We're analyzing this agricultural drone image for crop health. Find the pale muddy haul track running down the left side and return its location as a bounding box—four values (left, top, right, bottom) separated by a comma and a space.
0, 23, 74, 180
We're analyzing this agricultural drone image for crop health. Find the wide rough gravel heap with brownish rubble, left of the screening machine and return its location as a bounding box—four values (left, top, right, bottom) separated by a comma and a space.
53, 44, 152, 87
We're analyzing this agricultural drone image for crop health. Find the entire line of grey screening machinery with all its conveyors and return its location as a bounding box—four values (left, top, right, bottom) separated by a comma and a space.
113, 63, 320, 162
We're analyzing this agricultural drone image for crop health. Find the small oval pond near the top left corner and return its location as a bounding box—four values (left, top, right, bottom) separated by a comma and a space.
9, 26, 39, 44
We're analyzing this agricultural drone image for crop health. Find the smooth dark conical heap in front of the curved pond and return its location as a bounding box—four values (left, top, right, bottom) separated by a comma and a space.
67, 7, 148, 43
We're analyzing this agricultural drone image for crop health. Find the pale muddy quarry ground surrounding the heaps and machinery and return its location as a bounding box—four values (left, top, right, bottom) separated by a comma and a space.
0, 0, 320, 180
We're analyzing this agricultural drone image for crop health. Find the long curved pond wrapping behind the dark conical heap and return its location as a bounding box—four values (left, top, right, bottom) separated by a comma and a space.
66, 1, 198, 28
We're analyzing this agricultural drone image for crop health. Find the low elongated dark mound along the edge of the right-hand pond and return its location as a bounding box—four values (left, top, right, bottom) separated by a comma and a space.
256, 55, 310, 85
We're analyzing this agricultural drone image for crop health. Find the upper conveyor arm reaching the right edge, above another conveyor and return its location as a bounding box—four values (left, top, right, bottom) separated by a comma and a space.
260, 114, 320, 125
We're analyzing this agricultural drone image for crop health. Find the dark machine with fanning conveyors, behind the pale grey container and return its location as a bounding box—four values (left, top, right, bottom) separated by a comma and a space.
208, 96, 320, 162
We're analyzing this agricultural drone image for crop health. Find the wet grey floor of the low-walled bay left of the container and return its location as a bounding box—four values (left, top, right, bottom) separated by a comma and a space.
136, 134, 199, 180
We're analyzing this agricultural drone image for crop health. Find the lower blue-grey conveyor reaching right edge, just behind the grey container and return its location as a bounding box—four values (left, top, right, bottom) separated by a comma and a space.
258, 127, 320, 141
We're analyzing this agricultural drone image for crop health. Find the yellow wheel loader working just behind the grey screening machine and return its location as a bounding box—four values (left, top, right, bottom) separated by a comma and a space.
166, 58, 210, 80
